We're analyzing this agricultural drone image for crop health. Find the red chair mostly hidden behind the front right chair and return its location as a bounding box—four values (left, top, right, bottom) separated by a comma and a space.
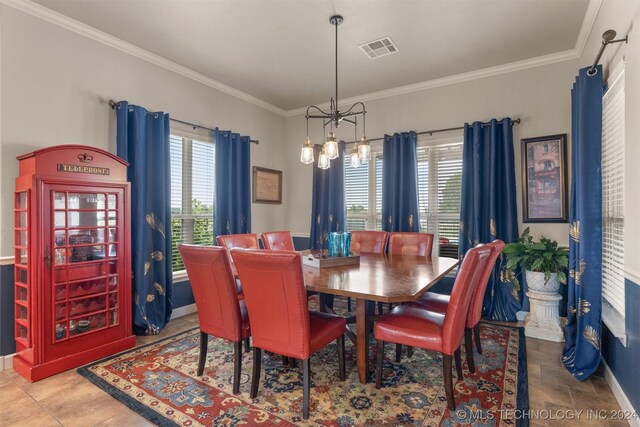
412, 239, 504, 373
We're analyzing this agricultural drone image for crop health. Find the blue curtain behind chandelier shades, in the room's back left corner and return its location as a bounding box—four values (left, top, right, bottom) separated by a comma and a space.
310, 141, 347, 249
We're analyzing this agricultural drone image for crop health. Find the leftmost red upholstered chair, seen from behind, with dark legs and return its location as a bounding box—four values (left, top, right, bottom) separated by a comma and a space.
178, 245, 251, 394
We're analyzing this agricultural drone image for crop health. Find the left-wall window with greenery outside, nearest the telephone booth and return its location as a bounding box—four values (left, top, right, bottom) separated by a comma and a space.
169, 134, 215, 274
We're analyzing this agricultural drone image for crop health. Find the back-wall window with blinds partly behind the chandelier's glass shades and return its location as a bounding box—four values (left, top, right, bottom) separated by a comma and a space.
344, 146, 382, 231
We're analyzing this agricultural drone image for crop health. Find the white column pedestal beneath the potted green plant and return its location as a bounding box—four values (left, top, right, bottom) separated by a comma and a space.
524, 290, 564, 342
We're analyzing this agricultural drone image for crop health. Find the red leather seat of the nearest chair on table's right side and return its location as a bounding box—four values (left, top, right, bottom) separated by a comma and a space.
375, 305, 444, 351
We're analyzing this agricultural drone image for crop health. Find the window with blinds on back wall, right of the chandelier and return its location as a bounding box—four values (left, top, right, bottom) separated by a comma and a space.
418, 141, 462, 257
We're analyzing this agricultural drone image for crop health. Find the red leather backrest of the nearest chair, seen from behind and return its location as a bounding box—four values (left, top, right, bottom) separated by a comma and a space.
231, 249, 311, 359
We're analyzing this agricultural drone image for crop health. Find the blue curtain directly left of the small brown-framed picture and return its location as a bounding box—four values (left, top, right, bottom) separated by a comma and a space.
218, 128, 251, 236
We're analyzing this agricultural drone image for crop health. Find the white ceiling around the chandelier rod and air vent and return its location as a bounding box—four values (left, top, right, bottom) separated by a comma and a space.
30, 0, 589, 110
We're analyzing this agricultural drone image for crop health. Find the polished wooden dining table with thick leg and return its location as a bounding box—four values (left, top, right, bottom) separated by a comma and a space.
302, 252, 459, 384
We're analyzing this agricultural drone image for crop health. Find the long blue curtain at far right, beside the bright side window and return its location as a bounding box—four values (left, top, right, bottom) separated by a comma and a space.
562, 66, 603, 381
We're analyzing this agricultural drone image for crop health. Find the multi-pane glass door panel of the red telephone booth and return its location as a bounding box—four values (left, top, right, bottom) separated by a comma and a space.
52, 191, 120, 341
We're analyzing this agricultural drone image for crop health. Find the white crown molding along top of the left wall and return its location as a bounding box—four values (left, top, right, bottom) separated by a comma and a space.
0, 0, 285, 116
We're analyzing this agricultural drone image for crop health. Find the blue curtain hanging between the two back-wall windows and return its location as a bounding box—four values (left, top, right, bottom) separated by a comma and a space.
382, 132, 420, 231
